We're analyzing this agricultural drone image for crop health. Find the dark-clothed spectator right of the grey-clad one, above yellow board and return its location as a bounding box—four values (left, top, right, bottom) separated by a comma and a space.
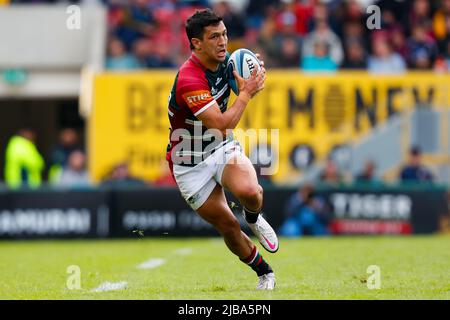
407, 25, 438, 69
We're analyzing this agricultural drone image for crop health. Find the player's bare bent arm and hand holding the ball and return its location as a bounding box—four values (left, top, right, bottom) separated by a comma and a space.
197, 68, 266, 135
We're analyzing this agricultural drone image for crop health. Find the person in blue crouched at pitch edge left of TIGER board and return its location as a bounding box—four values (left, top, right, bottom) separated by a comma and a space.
279, 185, 330, 237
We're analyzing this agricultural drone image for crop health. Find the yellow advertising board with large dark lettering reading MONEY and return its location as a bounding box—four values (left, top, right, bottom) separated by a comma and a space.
88, 71, 450, 182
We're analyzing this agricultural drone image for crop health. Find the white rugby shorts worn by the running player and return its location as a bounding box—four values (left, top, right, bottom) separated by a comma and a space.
173, 140, 246, 210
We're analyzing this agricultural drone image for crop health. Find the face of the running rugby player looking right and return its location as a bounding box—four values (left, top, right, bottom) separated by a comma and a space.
202, 21, 228, 63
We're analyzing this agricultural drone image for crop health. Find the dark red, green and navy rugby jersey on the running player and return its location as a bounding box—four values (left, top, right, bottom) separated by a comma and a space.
166, 54, 230, 169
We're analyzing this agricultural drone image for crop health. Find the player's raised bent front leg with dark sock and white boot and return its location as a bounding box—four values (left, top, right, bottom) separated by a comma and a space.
222, 156, 278, 253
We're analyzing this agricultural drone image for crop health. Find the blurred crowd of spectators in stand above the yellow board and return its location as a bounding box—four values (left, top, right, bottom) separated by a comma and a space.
7, 0, 450, 73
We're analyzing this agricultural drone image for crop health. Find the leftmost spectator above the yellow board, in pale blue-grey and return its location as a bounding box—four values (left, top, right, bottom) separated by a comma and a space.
106, 38, 141, 70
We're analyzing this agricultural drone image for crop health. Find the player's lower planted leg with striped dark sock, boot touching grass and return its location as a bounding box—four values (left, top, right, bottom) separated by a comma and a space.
197, 185, 275, 290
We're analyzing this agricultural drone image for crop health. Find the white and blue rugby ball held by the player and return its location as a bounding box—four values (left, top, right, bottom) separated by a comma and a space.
227, 48, 261, 95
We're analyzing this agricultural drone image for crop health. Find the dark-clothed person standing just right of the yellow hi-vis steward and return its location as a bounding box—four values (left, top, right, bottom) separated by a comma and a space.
48, 128, 81, 183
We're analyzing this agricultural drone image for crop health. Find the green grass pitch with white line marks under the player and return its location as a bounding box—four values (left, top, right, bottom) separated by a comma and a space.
0, 235, 450, 300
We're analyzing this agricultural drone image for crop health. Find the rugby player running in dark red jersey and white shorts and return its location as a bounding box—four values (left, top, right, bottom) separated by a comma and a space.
166, 9, 278, 290
